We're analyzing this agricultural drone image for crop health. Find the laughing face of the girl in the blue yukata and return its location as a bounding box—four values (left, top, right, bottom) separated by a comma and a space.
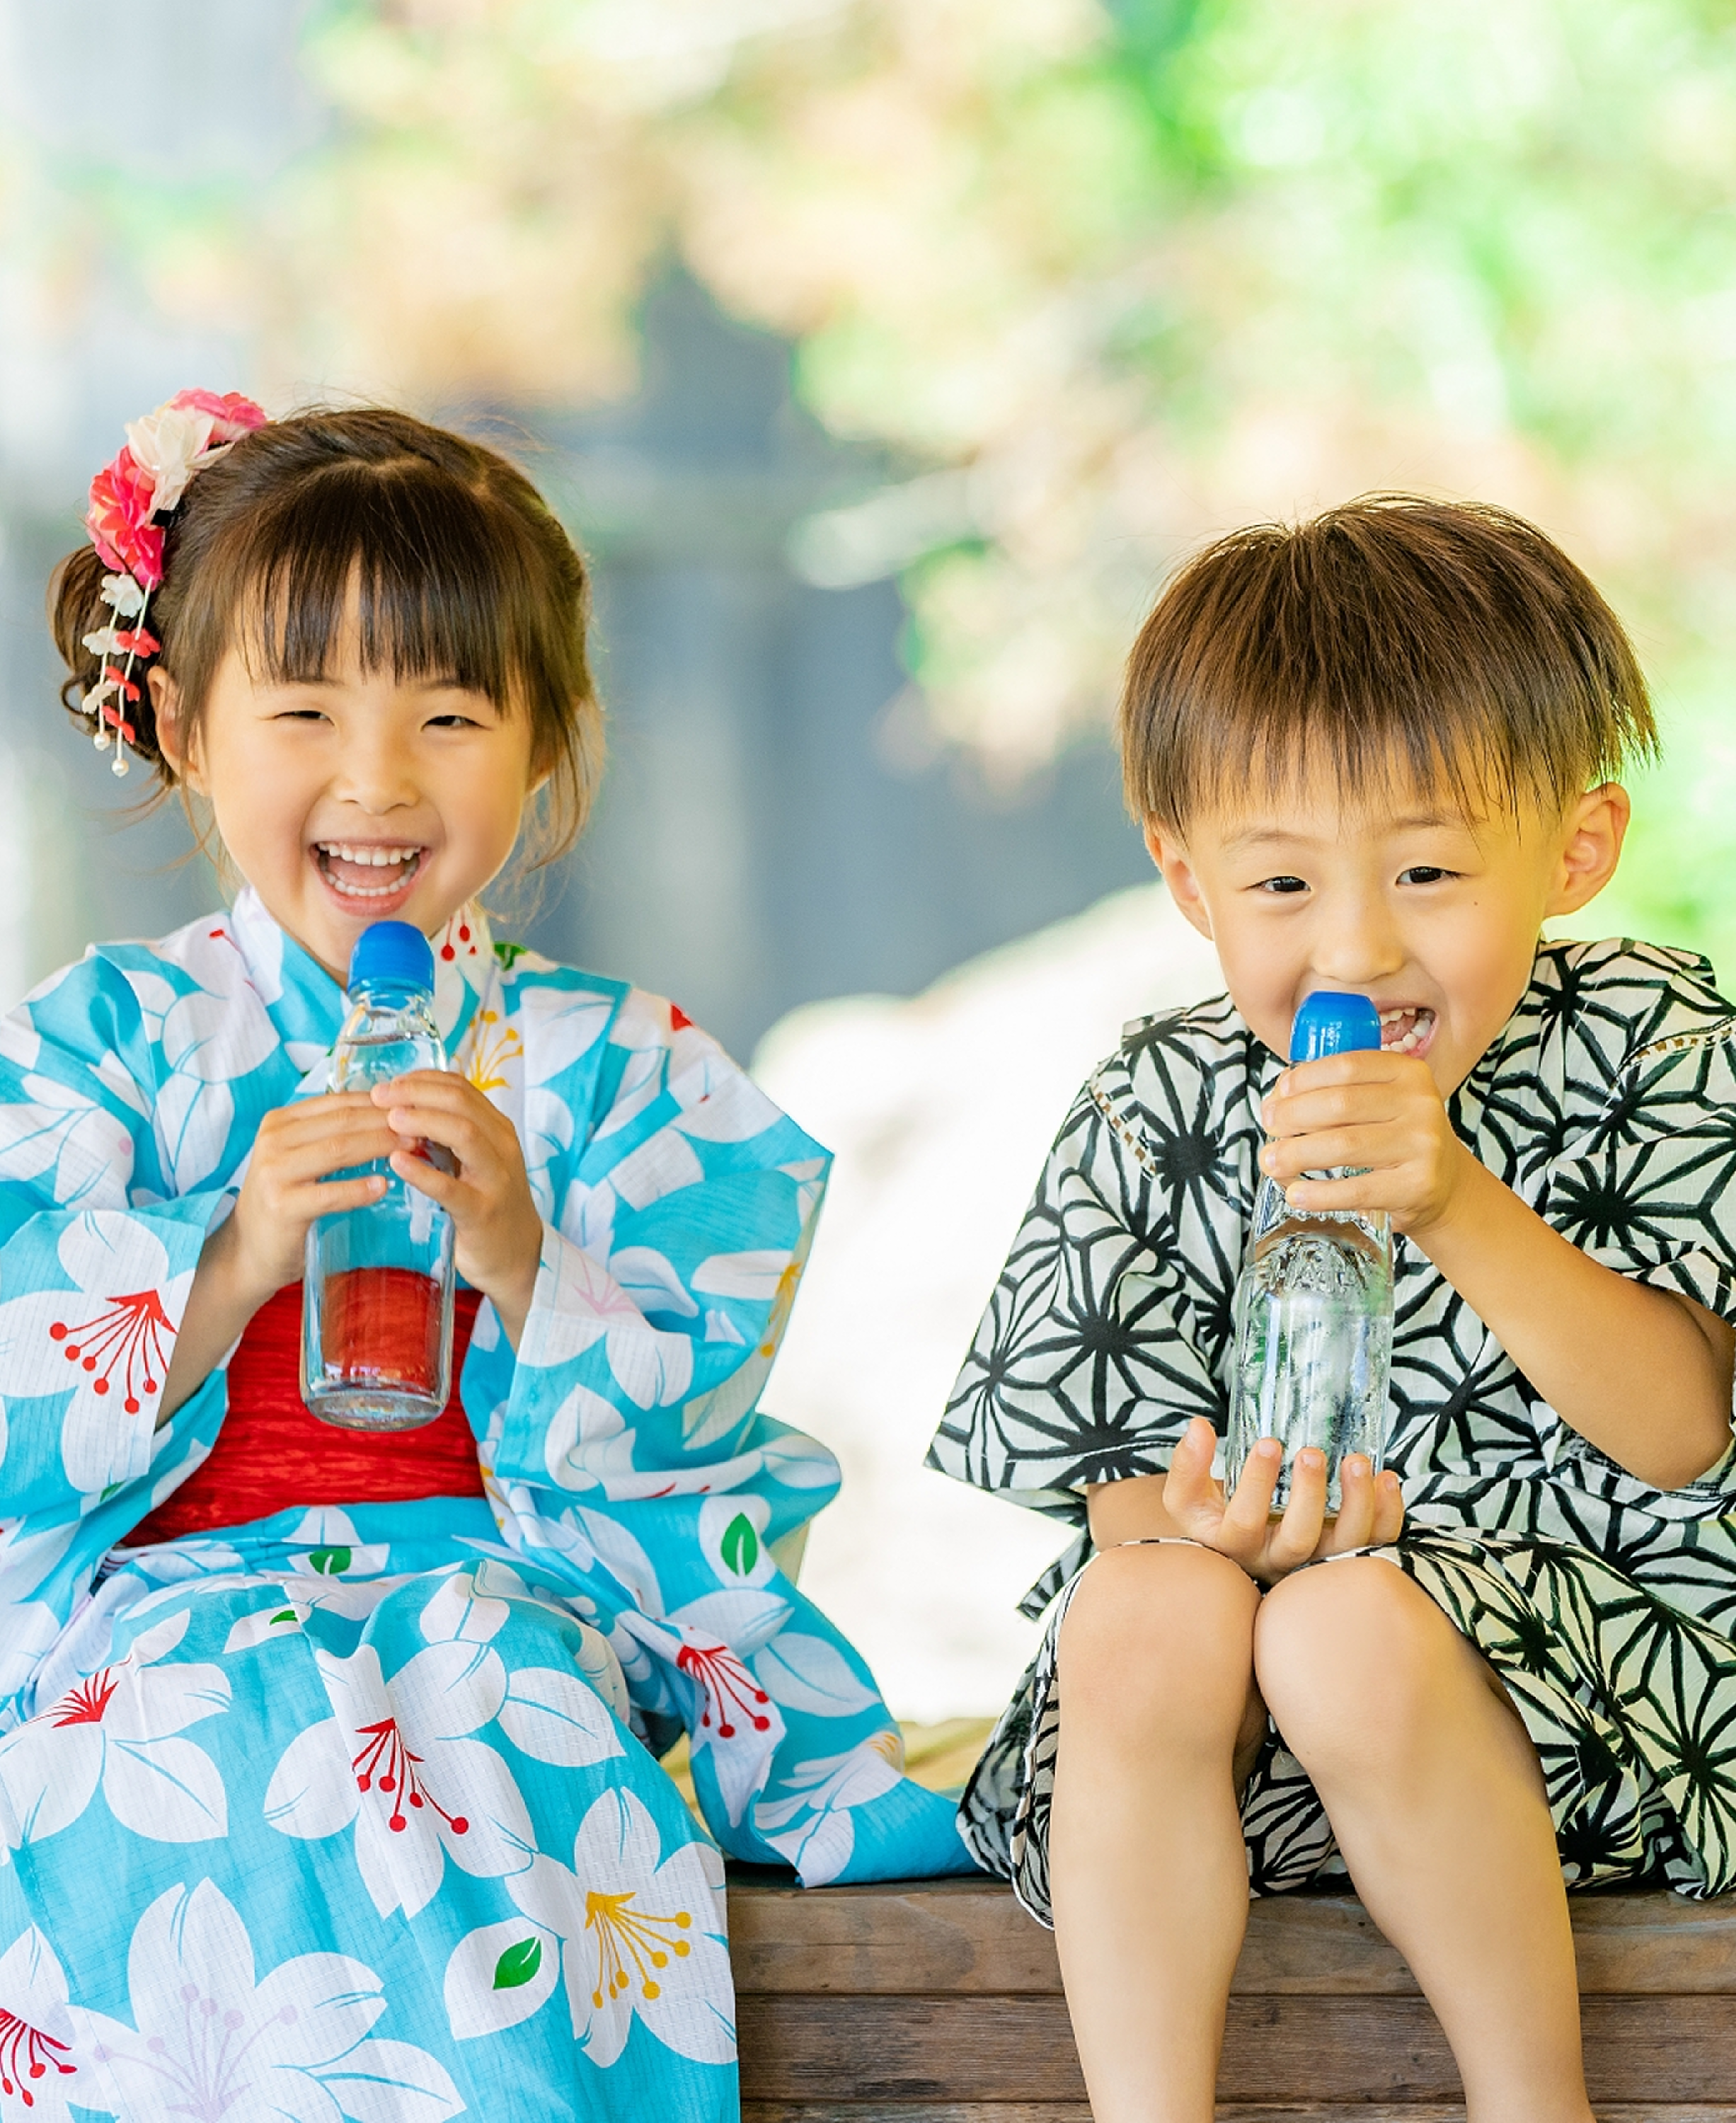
153, 616, 535, 981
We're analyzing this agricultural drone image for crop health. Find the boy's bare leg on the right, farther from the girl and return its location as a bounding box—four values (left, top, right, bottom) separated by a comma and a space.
1254, 1556, 1592, 2123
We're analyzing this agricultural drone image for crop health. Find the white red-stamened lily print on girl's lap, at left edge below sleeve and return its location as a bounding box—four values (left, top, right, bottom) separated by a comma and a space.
0, 1613, 229, 1849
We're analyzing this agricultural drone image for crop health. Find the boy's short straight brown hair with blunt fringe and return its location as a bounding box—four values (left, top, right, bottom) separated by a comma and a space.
1120, 495, 1657, 832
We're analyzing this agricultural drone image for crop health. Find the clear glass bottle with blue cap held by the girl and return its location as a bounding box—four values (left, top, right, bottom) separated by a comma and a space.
301, 921, 452, 1431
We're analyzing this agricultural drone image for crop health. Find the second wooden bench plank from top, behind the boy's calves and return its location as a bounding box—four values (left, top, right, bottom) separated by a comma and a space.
739, 1993, 1736, 2117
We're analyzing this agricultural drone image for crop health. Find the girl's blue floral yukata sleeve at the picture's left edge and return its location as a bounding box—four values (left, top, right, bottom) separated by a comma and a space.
0, 957, 225, 1537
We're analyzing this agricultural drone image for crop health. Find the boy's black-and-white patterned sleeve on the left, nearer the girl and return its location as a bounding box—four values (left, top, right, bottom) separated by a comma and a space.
927, 1062, 1243, 1554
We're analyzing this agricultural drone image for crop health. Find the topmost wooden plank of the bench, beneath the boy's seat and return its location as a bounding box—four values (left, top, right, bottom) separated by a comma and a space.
730, 1875, 1736, 1998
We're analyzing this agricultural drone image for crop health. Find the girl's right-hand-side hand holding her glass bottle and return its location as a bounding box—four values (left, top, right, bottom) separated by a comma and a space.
369, 1070, 544, 1348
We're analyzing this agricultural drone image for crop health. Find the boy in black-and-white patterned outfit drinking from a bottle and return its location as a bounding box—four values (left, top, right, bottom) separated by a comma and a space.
931, 499, 1736, 2123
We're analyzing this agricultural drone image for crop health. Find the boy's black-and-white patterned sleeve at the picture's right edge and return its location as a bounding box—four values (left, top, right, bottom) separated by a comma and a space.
1543, 1017, 1736, 1393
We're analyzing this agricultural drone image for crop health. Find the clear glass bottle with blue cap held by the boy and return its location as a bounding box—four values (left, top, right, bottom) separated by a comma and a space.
1226, 989, 1392, 1512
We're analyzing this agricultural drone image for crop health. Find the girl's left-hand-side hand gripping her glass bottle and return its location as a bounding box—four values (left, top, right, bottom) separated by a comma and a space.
219, 1091, 397, 1325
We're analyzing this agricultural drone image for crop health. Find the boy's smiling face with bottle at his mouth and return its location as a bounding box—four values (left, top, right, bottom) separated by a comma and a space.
1146, 777, 1628, 1098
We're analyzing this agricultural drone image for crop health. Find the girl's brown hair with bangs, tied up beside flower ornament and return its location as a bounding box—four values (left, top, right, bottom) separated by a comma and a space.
49, 408, 603, 862
